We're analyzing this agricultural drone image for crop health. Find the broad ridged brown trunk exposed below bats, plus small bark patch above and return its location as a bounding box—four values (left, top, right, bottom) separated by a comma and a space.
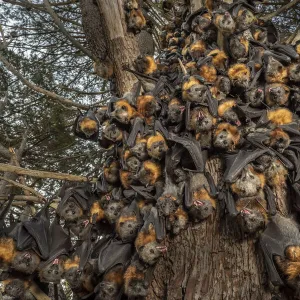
147, 158, 284, 300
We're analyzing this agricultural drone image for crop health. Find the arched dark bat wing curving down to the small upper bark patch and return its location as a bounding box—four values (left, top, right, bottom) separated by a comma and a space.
169, 133, 204, 172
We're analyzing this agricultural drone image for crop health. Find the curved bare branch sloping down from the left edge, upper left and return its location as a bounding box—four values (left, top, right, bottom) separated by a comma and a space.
0, 53, 89, 109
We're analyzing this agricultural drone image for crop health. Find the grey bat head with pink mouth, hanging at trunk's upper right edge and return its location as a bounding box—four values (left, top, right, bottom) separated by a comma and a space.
239, 208, 265, 233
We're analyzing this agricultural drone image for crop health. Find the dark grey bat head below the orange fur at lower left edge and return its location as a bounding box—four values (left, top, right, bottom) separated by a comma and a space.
12, 251, 40, 274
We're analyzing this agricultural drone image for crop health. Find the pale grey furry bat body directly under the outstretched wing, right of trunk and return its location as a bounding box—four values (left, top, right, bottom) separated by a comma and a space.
231, 166, 265, 197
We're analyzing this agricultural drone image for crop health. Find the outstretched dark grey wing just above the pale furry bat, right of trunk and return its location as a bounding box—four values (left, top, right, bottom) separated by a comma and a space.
224, 149, 268, 182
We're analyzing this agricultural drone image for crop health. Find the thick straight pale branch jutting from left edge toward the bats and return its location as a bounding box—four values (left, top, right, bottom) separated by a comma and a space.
0, 163, 96, 182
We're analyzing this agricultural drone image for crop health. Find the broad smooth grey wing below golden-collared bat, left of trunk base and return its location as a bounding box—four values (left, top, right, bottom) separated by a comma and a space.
98, 239, 134, 274
